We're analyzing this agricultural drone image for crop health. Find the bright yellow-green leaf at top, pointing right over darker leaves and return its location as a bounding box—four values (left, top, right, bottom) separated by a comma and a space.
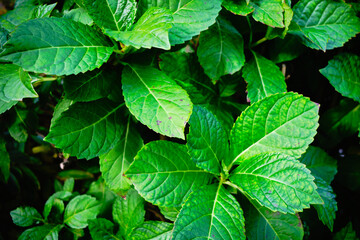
105, 7, 172, 50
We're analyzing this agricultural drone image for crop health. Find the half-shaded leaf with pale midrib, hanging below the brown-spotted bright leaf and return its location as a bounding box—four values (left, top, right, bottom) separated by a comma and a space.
100, 118, 143, 191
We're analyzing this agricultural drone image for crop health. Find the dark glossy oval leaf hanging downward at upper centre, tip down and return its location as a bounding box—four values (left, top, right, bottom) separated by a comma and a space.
197, 18, 245, 80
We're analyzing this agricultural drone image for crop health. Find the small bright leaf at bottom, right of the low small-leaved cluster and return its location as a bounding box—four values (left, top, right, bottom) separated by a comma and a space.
112, 189, 145, 239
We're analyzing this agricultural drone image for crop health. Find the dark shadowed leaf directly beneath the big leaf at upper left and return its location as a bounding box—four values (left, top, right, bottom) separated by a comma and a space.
64, 69, 117, 102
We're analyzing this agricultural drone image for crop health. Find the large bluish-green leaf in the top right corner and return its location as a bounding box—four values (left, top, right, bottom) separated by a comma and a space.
289, 0, 360, 51
